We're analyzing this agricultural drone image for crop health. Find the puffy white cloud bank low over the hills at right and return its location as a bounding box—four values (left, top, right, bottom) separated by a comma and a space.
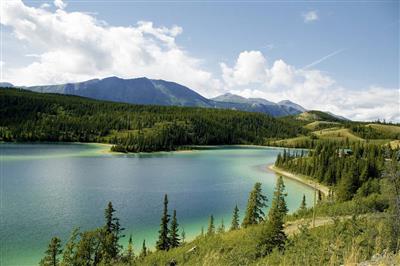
221, 51, 400, 122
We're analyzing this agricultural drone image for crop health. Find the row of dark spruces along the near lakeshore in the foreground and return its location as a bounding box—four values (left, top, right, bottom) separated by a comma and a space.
39, 177, 288, 266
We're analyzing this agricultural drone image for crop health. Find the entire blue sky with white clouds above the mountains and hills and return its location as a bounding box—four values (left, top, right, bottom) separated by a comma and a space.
2, 0, 400, 121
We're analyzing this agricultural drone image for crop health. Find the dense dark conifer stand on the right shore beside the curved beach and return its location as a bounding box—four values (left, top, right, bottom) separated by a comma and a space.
275, 141, 399, 201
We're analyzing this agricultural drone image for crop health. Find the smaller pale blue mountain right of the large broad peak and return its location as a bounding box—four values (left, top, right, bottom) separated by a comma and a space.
211, 93, 305, 116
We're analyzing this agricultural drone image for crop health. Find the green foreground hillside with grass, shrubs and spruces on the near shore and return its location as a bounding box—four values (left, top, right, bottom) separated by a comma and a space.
41, 145, 400, 265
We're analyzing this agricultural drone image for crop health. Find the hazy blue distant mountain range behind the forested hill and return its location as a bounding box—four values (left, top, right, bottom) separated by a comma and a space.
0, 77, 306, 117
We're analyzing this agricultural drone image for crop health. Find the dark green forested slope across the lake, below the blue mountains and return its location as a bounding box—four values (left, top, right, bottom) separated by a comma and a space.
0, 88, 304, 152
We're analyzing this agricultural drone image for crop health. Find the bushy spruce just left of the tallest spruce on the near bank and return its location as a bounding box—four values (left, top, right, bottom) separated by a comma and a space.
242, 182, 267, 227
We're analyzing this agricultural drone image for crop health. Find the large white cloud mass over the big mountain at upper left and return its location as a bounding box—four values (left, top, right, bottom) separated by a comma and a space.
1, 0, 220, 95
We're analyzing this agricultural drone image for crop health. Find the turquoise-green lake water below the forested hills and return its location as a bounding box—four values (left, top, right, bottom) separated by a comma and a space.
0, 144, 312, 265
